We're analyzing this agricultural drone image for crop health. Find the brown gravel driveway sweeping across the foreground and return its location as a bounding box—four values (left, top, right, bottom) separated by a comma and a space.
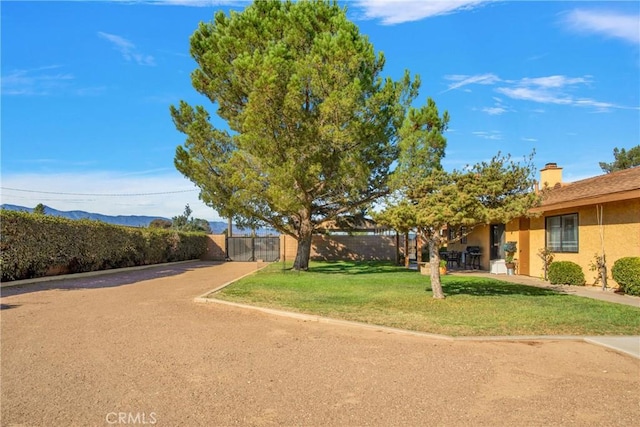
1, 262, 640, 426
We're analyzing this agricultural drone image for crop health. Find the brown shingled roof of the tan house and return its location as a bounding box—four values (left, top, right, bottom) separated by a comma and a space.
531, 167, 640, 212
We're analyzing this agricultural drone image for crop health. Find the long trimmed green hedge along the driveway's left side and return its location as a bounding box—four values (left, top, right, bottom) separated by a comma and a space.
0, 210, 207, 282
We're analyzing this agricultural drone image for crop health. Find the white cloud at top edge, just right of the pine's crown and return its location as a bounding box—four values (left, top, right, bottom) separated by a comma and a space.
354, 0, 492, 25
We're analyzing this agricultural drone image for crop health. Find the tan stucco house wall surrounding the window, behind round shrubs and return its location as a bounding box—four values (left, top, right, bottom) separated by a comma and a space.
529, 199, 640, 286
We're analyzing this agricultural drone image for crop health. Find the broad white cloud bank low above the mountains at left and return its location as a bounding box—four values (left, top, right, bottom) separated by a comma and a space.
0, 169, 220, 221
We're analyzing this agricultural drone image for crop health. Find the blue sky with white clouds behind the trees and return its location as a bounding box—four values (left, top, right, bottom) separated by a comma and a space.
0, 0, 640, 220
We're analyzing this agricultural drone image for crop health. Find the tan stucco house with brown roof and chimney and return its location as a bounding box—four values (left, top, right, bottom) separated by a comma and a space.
449, 163, 640, 286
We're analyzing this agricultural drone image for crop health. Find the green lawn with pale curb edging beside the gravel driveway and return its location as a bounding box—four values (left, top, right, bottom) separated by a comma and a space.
209, 262, 640, 336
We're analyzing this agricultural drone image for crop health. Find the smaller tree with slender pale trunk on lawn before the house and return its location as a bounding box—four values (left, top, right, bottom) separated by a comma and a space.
379, 126, 539, 298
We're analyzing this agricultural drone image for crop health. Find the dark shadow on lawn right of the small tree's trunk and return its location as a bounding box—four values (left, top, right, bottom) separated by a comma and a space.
438, 279, 566, 297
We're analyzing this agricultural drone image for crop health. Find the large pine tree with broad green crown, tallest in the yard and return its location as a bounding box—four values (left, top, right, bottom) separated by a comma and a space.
171, 0, 419, 269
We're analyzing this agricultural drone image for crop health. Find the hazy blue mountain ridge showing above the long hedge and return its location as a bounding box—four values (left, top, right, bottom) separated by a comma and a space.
0, 204, 264, 235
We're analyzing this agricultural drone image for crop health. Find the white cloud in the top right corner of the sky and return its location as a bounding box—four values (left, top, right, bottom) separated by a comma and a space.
564, 9, 640, 44
